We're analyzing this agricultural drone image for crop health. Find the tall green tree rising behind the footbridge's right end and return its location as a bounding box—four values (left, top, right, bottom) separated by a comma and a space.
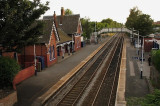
125, 7, 153, 36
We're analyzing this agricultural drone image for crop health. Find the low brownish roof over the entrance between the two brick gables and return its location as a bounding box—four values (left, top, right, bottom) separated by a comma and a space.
58, 28, 72, 44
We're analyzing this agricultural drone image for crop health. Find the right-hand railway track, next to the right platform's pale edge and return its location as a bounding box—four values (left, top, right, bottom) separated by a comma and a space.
88, 35, 123, 106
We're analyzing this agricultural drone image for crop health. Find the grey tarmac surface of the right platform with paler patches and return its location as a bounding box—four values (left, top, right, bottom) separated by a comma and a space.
125, 37, 150, 98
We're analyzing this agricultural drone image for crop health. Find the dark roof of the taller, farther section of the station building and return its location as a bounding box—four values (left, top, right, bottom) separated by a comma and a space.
43, 14, 80, 34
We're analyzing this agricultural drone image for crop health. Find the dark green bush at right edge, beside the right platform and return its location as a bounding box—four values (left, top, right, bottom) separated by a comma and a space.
151, 50, 160, 71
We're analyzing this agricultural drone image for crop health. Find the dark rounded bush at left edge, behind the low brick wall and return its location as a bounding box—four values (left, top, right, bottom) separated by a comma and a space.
0, 57, 20, 89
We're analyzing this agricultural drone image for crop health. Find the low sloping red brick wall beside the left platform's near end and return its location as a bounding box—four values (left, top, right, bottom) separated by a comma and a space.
13, 66, 35, 90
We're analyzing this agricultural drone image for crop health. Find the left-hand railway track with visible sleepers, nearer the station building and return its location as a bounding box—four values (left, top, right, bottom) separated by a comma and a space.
54, 33, 122, 106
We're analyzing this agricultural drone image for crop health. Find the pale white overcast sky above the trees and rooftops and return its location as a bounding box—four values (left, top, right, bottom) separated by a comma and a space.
41, 0, 160, 23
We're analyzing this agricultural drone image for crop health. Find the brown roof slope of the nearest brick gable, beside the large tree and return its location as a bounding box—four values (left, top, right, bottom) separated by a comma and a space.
38, 20, 53, 43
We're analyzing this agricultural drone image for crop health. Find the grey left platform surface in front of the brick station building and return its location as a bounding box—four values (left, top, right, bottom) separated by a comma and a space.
15, 37, 109, 106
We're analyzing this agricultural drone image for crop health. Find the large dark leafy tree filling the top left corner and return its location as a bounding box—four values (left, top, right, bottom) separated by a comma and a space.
0, 0, 49, 51
